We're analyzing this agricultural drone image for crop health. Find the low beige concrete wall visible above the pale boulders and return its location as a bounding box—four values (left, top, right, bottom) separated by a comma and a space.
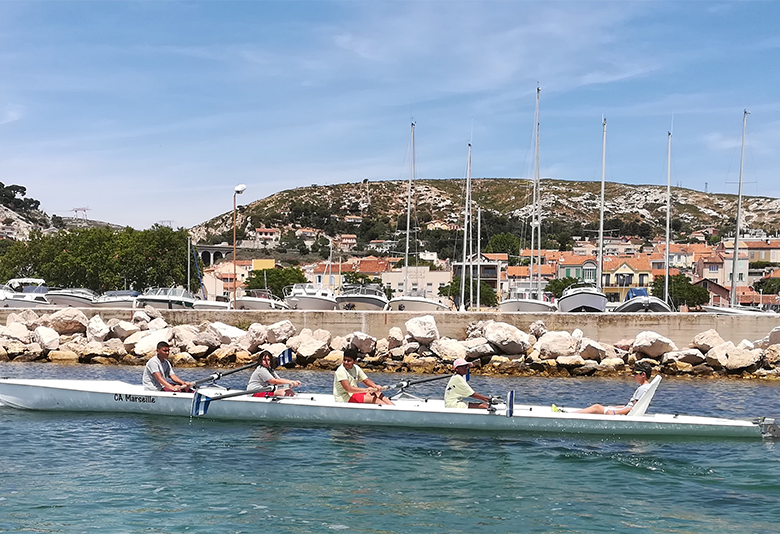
0, 308, 780, 348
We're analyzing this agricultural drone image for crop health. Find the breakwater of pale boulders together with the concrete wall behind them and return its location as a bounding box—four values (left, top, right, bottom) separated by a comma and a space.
0, 307, 780, 380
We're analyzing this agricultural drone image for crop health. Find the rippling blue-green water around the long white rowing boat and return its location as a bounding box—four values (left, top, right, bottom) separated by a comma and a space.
0, 364, 780, 533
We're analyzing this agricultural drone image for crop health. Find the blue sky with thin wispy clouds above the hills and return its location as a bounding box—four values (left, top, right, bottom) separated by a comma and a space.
0, 0, 780, 229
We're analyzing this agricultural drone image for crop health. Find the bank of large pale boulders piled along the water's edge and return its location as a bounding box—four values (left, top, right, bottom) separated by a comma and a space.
0, 307, 780, 379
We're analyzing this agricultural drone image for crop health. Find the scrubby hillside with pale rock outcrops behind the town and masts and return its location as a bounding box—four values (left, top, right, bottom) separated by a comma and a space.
191, 178, 780, 242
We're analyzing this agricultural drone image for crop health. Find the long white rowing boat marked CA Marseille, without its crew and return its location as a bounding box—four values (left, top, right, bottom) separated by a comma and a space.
0, 379, 780, 438
